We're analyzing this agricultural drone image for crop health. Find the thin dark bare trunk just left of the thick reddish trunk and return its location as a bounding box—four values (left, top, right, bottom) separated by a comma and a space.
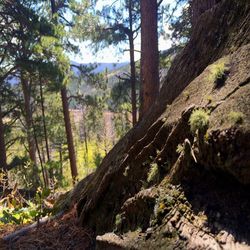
129, 0, 137, 126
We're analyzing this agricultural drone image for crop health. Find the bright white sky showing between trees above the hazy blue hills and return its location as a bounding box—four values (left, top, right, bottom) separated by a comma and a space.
69, 0, 175, 63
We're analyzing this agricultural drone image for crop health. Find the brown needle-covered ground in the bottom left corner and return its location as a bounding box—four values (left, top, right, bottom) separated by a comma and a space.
0, 209, 93, 250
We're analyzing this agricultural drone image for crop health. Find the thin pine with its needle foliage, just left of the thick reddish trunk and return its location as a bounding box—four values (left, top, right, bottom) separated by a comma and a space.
93, 0, 140, 126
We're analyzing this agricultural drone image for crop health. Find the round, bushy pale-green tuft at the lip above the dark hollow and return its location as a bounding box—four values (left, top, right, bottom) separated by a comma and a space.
189, 109, 209, 133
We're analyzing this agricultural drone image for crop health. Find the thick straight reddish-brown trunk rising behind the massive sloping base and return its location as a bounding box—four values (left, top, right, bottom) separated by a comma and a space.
140, 0, 160, 119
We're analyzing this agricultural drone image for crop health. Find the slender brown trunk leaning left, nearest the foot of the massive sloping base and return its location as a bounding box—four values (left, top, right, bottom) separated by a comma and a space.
61, 87, 78, 183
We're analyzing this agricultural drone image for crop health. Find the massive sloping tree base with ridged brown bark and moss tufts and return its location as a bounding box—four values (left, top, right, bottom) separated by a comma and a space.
73, 0, 250, 249
